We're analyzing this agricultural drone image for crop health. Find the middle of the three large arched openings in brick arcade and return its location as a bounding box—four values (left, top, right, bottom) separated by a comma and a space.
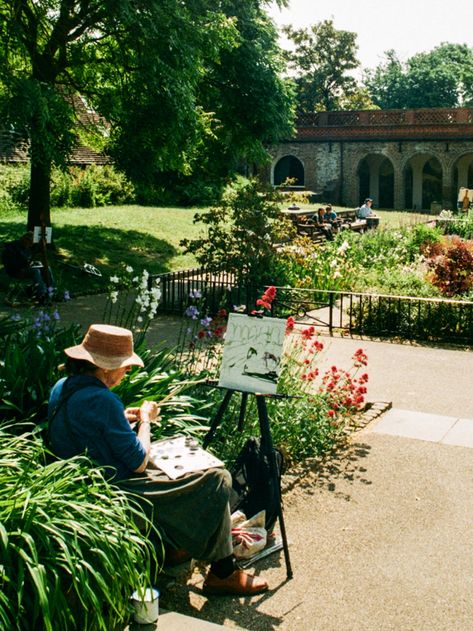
403, 153, 445, 210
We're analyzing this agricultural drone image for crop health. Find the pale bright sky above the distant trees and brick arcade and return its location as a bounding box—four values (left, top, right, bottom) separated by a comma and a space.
269, 0, 473, 68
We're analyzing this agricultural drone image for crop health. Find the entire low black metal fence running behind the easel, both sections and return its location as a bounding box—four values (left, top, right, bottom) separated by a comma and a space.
153, 268, 473, 345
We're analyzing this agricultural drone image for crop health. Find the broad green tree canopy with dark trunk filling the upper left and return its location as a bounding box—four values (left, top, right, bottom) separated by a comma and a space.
0, 0, 292, 226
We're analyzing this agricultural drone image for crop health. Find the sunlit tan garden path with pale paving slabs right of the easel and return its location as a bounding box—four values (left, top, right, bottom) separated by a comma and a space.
1, 297, 473, 631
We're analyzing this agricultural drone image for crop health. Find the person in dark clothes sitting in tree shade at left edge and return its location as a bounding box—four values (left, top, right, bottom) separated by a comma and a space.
2, 232, 48, 300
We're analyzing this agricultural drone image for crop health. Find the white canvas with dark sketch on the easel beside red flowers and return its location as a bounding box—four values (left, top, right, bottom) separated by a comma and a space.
218, 313, 286, 394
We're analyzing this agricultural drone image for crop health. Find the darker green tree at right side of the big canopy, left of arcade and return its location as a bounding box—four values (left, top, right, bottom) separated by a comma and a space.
149, 0, 295, 203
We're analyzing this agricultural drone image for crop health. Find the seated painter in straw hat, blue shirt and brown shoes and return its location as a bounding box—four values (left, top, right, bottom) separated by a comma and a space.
48, 324, 268, 596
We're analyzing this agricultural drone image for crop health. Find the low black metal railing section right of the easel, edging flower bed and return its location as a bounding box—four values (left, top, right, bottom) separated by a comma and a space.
272, 287, 473, 345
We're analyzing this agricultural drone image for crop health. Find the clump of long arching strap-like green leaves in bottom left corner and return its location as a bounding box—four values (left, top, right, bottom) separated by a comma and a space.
0, 428, 156, 631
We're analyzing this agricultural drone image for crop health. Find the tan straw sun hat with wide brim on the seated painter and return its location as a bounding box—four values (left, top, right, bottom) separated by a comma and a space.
64, 324, 144, 370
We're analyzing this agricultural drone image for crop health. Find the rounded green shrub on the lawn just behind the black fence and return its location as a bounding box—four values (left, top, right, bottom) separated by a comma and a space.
181, 180, 283, 287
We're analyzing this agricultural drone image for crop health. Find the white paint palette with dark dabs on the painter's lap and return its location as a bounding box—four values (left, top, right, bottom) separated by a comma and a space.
150, 436, 225, 480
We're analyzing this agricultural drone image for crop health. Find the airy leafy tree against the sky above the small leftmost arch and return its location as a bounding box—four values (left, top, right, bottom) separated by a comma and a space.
283, 20, 360, 112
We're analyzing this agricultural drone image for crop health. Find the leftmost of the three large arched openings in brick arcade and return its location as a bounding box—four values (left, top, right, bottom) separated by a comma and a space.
356, 153, 394, 208
